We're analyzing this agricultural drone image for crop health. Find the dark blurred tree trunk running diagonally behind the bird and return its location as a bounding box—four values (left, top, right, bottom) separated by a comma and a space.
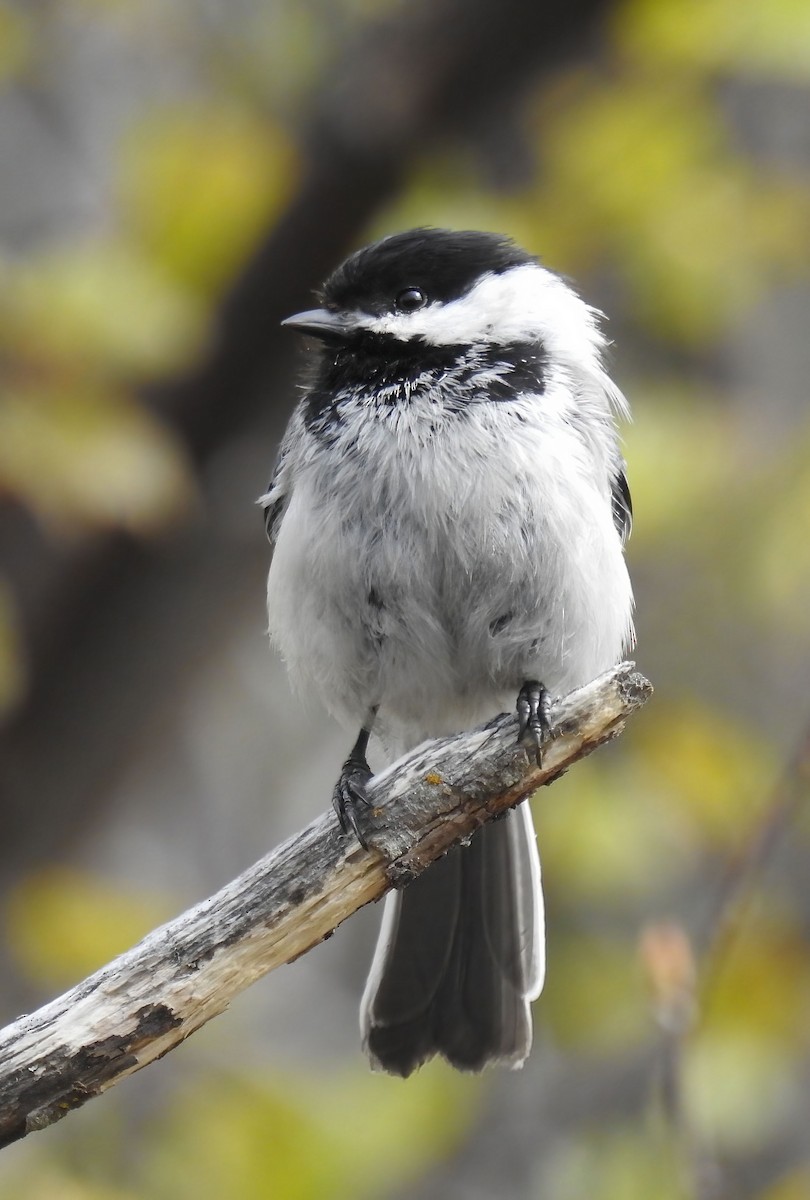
0, 0, 611, 880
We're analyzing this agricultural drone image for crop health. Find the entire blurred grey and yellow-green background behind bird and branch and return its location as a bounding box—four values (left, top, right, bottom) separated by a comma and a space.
0, 0, 810, 1200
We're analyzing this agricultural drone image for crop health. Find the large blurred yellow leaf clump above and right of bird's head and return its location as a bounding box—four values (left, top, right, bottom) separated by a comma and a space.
535, 75, 810, 344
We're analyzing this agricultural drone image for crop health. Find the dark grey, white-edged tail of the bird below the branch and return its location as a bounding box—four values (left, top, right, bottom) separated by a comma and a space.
360, 804, 545, 1076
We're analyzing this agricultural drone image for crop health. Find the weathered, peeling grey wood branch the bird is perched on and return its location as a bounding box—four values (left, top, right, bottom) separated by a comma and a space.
0, 662, 652, 1146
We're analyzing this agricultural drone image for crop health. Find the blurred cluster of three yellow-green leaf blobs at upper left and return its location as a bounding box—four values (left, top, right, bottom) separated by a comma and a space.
0, 77, 296, 534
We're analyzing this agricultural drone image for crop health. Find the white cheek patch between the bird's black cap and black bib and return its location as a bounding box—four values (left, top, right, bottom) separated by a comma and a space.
360, 263, 605, 374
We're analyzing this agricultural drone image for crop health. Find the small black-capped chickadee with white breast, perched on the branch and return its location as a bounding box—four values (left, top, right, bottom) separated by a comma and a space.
259, 227, 634, 1076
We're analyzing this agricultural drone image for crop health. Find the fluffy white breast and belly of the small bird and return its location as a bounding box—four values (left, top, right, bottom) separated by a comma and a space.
268, 382, 632, 739
